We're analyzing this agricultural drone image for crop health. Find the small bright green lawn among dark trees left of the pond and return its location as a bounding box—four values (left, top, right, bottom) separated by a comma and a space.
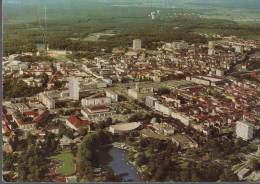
52, 151, 76, 176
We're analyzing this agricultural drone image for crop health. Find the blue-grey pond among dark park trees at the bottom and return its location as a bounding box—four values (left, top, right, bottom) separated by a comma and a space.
100, 147, 142, 181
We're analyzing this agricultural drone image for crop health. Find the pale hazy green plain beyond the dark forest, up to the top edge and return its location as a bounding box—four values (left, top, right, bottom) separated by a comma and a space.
3, 0, 260, 26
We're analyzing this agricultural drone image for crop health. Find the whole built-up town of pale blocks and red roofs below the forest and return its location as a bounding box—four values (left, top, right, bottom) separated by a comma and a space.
2, 37, 260, 182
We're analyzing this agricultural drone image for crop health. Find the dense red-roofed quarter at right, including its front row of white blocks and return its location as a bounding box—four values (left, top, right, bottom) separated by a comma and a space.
142, 78, 259, 135
